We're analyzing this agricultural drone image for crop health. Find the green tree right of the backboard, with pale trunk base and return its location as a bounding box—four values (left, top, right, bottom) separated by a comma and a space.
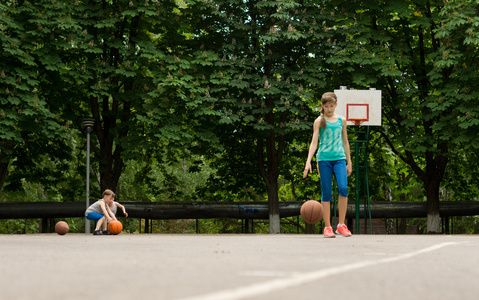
328, 0, 479, 232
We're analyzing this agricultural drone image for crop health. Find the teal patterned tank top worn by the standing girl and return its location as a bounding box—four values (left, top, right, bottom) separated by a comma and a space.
316, 116, 346, 161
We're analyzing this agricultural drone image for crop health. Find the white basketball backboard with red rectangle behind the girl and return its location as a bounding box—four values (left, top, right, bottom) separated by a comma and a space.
334, 89, 382, 126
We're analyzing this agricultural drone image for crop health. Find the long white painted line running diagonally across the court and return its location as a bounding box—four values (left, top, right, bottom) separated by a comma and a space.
183, 242, 457, 300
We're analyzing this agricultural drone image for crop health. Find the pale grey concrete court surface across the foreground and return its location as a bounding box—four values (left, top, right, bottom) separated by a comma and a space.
0, 234, 479, 300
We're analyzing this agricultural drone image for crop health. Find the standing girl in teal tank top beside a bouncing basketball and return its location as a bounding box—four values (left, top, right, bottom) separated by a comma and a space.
303, 92, 352, 238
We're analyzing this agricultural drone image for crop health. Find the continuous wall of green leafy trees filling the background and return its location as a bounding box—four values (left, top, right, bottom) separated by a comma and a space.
0, 0, 479, 232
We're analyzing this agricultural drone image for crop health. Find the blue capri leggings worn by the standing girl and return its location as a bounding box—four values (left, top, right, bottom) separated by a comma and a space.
318, 159, 348, 202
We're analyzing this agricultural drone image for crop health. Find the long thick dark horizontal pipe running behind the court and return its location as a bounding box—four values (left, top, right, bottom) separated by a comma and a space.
0, 201, 479, 219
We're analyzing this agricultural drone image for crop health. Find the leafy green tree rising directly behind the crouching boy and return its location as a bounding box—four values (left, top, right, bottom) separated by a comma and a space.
59, 1, 192, 190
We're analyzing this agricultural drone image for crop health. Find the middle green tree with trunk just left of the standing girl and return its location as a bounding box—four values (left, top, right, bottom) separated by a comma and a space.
186, 0, 332, 233
